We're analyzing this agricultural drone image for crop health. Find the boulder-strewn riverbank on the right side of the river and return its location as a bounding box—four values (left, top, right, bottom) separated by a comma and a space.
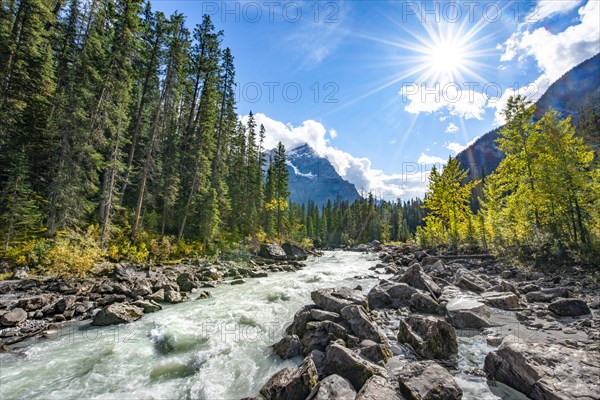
246, 246, 600, 400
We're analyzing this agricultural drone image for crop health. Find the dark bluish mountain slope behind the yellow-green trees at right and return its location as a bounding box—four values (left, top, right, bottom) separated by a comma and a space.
457, 54, 600, 179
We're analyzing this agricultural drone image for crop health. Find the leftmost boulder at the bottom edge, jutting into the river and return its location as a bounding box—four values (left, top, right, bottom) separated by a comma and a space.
260, 358, 318, 400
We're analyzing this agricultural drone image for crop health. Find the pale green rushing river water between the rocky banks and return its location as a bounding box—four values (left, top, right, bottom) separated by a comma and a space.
0, 252, 504, 400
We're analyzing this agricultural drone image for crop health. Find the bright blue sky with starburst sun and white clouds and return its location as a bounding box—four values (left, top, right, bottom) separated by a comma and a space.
153, 0, 600, 199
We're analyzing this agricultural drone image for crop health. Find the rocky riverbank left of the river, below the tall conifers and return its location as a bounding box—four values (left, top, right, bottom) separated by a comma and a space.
0, 243, 307, 351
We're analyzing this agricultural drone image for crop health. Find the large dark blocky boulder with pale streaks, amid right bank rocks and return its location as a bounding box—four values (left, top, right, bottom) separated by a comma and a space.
398, 315, 458, 359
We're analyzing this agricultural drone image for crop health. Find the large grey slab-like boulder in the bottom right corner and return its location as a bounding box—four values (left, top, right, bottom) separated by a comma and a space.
484, 342, 600, 400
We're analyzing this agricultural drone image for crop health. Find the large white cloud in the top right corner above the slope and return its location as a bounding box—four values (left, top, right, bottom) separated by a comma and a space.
501, 0, 600, 82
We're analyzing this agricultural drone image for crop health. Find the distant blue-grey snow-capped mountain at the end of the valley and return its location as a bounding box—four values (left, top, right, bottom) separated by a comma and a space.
266, 144, 360, 206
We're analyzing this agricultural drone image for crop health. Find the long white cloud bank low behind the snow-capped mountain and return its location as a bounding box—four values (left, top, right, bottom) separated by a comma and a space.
241, 113, 432, 200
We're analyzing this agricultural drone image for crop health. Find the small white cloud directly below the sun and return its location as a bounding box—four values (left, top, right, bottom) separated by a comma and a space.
400, 82, 487, 120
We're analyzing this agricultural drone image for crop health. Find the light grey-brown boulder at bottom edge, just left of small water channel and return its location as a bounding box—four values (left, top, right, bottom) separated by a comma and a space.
393, 361, 462, 400
